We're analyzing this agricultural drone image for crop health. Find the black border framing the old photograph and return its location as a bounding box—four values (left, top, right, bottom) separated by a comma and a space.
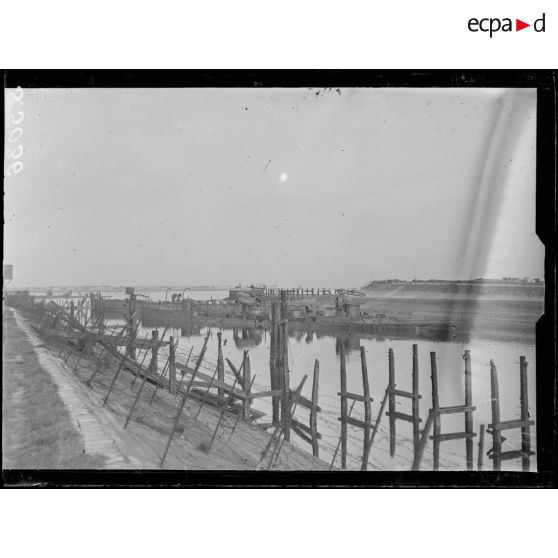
2, 70, 558, 488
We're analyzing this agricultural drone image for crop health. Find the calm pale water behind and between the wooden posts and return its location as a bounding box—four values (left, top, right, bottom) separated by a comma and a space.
104, 310, 536, 471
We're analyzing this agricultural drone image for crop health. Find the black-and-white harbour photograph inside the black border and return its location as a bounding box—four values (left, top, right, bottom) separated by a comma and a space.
2, 76, 550, 476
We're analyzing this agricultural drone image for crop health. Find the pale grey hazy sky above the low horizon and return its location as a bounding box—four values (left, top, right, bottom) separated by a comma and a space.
4, 88, 544, 287
